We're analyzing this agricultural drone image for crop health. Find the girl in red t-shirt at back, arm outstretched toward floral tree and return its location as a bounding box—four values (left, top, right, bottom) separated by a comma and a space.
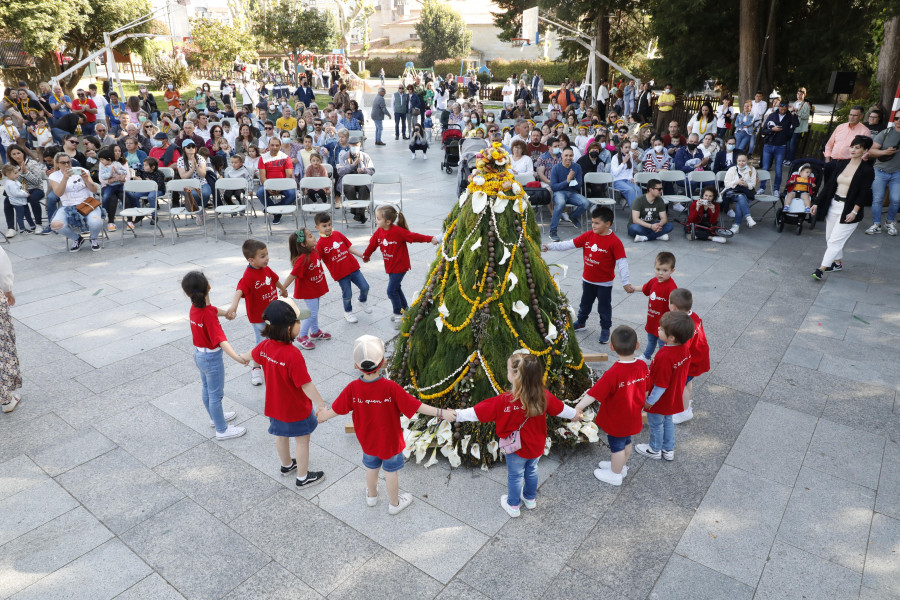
363, 204, 441, 328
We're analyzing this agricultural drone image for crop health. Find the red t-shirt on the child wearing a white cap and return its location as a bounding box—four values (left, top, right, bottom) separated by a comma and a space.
331, 377, 422, 460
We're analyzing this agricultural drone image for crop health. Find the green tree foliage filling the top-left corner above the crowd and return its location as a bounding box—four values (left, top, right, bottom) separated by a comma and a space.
0, 0, 151, 88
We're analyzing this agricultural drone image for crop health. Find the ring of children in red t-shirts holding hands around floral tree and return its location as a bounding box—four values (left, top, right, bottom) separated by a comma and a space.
182, 200, 709, 517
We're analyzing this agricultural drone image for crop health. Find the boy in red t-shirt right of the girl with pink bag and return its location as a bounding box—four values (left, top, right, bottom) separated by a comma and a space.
575, 325, 650, 485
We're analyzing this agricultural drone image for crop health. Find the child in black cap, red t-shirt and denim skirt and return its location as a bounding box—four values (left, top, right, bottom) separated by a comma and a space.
242, 300, 326, 487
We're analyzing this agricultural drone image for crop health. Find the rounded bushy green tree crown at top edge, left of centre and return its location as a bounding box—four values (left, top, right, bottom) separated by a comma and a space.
253, 0, 339, 53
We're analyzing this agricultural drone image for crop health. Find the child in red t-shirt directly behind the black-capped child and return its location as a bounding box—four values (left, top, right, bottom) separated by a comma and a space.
225, 239, 287, 385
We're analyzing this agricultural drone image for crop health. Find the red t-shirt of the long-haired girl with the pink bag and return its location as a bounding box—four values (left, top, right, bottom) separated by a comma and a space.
474, 390, 566, 459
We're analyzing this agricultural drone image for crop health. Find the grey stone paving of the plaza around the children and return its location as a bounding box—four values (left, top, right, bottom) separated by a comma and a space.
0, 129, 900, 600
